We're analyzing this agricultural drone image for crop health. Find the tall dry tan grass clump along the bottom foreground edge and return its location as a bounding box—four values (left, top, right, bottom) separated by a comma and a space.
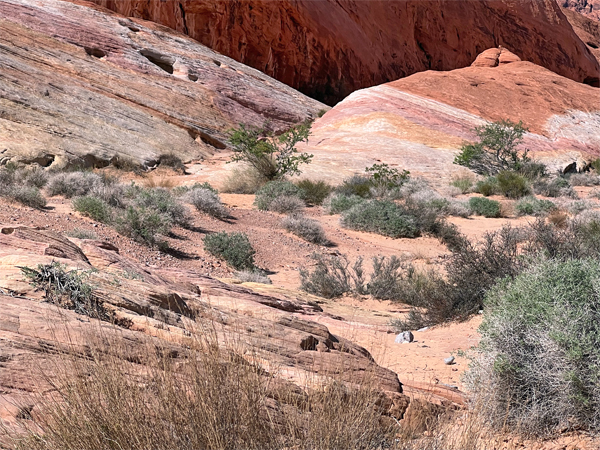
5, 324, 398, 450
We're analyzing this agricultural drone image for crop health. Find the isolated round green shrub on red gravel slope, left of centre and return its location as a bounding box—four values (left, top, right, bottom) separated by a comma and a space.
204, 231, 256, 270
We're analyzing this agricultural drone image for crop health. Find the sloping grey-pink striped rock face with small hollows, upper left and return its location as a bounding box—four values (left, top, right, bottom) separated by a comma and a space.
0, 0, 325, 166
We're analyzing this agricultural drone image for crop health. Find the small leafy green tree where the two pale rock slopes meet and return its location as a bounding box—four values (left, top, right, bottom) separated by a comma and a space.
229, 122, 313, 180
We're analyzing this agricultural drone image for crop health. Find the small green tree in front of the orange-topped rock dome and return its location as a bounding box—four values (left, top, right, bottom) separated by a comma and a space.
454, 120, 530, 175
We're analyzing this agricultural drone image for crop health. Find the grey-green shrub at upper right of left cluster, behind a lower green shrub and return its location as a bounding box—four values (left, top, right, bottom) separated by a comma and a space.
127, 184, 190, 227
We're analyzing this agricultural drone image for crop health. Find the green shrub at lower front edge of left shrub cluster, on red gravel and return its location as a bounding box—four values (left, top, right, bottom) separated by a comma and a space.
115, 206, 173, 246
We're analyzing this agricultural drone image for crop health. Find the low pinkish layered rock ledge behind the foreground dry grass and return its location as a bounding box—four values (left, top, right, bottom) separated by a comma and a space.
0, 225, 409, 428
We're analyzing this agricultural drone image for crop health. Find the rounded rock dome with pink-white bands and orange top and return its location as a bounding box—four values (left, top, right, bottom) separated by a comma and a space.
306, 49, 600, 185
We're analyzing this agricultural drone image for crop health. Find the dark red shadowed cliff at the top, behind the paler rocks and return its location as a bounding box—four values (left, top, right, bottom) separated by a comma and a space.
94, 0, 600, 104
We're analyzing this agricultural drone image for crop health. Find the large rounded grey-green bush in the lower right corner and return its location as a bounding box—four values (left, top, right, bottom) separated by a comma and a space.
466, 260, 600, 435
